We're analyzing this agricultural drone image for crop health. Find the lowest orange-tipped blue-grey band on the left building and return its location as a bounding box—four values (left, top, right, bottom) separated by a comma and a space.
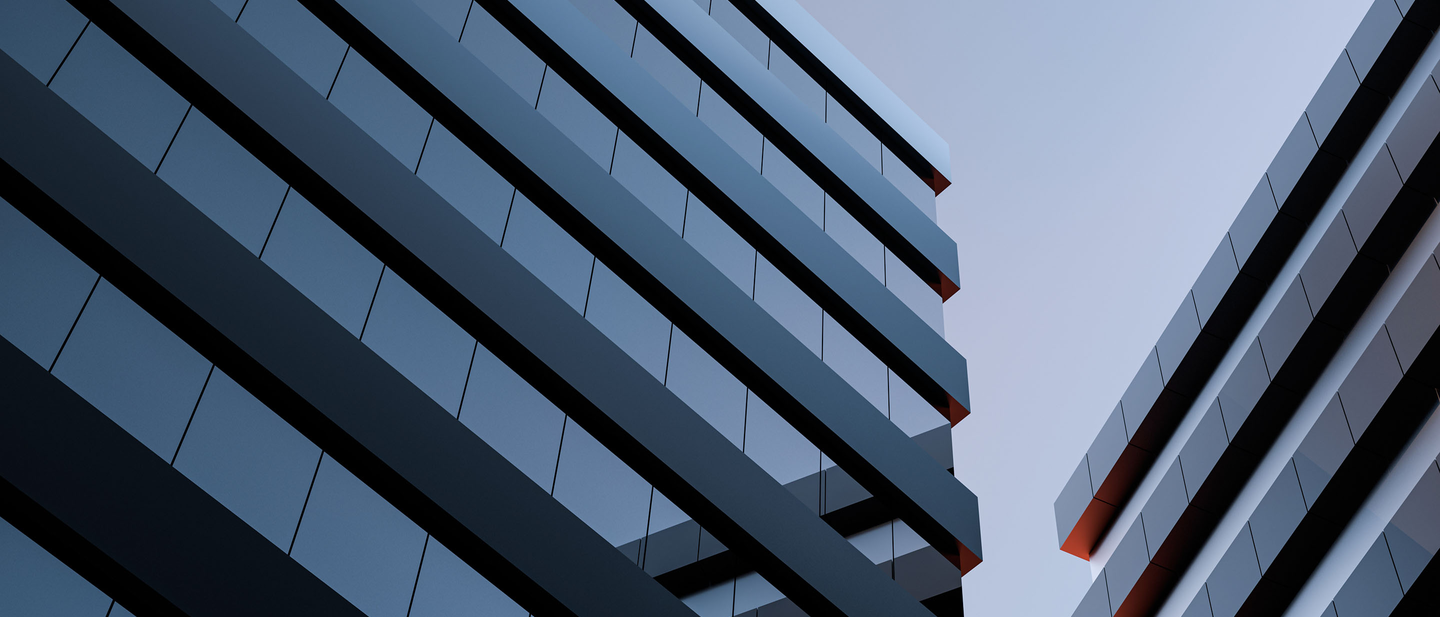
305, 0, 981, 567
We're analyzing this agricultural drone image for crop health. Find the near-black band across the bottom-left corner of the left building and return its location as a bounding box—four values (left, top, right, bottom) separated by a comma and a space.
0, 334, 361, 617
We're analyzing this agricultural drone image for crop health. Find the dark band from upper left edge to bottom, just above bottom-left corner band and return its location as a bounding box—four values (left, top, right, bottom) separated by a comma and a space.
0, 44, 696, 616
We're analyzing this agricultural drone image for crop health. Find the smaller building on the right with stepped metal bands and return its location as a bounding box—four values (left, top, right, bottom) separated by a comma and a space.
1056, 0, 1440, 617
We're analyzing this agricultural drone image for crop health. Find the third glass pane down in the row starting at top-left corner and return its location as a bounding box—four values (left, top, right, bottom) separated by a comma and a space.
158, 110, 285, 255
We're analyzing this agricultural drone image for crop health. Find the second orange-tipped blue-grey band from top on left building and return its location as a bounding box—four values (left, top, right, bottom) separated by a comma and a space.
618, 0, 960, 298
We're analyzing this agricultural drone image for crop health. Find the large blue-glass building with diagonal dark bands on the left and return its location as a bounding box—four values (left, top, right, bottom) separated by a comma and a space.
0, 0, 982, 617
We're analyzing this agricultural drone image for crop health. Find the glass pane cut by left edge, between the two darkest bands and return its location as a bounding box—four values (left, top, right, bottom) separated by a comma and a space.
0, 199, 99, 369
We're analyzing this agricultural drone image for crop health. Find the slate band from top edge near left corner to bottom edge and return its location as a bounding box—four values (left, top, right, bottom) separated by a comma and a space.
50, 0, 944, 616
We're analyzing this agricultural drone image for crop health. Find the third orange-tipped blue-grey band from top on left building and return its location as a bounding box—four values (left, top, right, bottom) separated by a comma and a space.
466, 0, 969, 424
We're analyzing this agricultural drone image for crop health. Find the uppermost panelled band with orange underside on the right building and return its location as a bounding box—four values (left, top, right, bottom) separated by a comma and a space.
1056, 0, 1440, 559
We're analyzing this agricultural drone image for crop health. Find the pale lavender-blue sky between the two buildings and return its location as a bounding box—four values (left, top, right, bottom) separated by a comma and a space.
799, 0, 1371, 617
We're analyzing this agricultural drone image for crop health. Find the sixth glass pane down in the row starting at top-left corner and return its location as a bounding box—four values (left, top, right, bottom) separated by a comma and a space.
459, 345, 564, 492
